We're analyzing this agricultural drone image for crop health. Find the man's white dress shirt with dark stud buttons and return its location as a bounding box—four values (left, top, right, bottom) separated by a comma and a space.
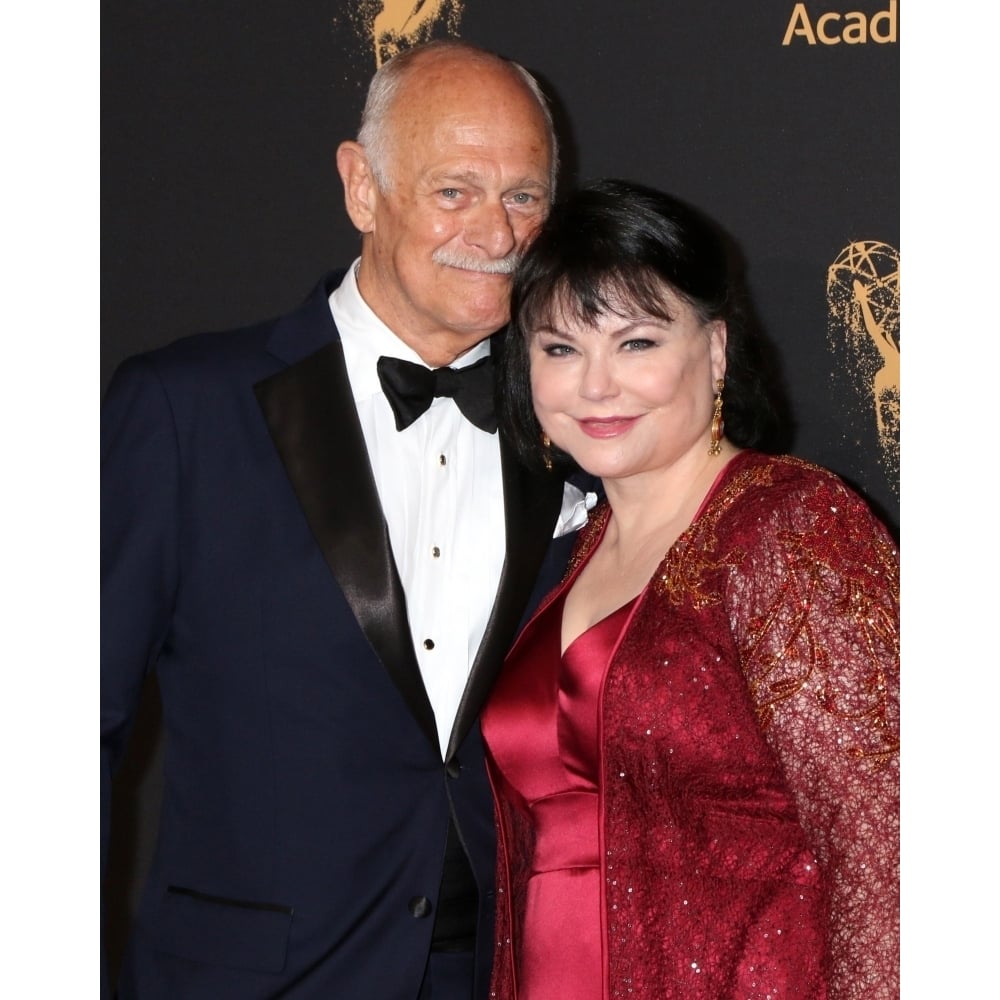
330, 262, 506, 757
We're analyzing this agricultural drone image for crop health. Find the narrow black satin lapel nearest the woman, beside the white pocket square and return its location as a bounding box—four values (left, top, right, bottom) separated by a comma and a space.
445, 436, 563, 760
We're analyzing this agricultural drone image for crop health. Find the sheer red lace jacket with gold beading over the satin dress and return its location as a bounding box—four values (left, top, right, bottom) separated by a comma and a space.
492, 452, 899, 1000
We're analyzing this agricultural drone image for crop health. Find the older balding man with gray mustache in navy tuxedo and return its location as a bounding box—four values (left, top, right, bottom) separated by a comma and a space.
101, 42, 580, 1000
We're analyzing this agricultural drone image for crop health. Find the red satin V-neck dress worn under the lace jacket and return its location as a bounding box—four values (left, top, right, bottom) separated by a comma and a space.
483, 598, 634, 1000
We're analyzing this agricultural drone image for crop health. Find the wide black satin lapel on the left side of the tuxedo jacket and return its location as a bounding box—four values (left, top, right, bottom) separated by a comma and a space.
254, 341, 438, 746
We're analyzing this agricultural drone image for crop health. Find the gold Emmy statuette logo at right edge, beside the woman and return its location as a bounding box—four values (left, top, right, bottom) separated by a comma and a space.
826, 240, 899, 496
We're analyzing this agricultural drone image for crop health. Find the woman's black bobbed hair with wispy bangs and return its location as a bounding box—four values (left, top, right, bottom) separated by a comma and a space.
497, 179, 776, 468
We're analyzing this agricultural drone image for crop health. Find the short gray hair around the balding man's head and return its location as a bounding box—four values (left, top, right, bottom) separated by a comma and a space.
357, 38, 559, 197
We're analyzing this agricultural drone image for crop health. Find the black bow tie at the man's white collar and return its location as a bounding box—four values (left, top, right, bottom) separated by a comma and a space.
377, 356, 497, 434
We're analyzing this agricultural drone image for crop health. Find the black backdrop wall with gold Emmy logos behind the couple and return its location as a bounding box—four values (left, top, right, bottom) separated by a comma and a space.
101, 0, 901, 976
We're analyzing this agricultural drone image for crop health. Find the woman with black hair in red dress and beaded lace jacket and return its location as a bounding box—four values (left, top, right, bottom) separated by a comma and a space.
483, 181, 899, 1000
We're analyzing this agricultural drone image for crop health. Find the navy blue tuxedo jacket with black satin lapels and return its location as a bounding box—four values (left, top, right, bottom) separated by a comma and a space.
101, 275, 569, 1000
